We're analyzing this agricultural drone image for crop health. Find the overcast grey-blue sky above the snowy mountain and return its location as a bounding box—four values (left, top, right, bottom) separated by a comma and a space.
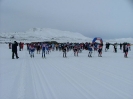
0, 0, 133, 39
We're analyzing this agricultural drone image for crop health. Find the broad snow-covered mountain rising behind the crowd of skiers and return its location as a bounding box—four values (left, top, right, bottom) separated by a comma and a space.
0, 28, 92, 42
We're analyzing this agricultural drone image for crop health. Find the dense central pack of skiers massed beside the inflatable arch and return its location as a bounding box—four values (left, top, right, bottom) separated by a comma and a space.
27, 43, 103, 58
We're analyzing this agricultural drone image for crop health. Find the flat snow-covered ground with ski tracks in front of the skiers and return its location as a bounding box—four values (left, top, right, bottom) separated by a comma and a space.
0, 44, 133, 99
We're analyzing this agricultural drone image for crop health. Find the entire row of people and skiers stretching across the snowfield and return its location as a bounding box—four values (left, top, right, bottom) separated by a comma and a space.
9, 41, 131, 59
